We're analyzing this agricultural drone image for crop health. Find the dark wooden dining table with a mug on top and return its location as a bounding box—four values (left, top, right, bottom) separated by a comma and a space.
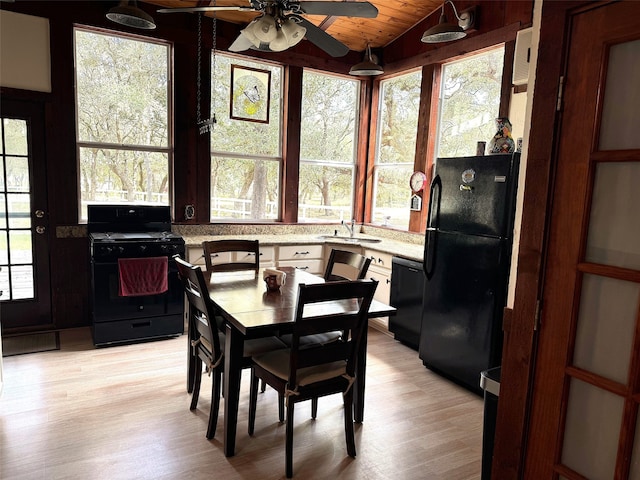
205, 267, 396, 457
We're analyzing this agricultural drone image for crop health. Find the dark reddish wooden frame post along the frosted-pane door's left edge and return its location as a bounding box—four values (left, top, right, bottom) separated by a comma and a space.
492, 1, 612, 479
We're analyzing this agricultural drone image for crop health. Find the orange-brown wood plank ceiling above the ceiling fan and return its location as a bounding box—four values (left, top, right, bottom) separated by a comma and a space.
144, 0, 442, 52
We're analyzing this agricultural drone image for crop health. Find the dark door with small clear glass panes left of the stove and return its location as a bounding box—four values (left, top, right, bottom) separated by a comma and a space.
0, 99, 51, 333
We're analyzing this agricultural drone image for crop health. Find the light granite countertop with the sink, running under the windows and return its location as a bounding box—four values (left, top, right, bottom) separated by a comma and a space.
183, 233, 424, 262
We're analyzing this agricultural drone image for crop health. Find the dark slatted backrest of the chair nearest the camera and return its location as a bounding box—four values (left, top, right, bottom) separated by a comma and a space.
288, 280, 378, 385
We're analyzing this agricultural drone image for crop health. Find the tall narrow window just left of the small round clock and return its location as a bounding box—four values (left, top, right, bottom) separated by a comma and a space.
371, 70, 422, 230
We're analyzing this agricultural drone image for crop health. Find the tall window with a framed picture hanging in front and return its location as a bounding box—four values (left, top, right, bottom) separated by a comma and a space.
211, 53, 282, 221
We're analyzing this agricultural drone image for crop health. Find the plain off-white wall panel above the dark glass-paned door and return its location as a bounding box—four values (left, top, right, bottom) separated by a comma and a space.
0, 10, 51, 92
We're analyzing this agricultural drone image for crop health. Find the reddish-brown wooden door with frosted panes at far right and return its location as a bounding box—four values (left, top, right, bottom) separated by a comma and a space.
525, 1, 640, 480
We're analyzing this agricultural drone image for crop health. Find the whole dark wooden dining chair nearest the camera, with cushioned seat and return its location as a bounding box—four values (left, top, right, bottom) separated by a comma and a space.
249, 280, 378, 478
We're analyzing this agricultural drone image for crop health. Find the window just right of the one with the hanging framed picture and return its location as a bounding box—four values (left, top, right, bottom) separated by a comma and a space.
298, 70, 359, 222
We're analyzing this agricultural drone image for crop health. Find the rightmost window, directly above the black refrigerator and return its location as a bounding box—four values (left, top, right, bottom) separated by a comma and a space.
436, 47, 504, 157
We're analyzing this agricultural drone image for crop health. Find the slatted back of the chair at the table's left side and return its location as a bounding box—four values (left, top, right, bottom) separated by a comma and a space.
174, 255, 222, 363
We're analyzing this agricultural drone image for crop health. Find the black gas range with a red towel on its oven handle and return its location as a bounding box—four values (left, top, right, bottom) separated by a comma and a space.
87, 205, 185, 346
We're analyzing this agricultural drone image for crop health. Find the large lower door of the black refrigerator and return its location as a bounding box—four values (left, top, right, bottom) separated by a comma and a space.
419, 232, 506, 393
